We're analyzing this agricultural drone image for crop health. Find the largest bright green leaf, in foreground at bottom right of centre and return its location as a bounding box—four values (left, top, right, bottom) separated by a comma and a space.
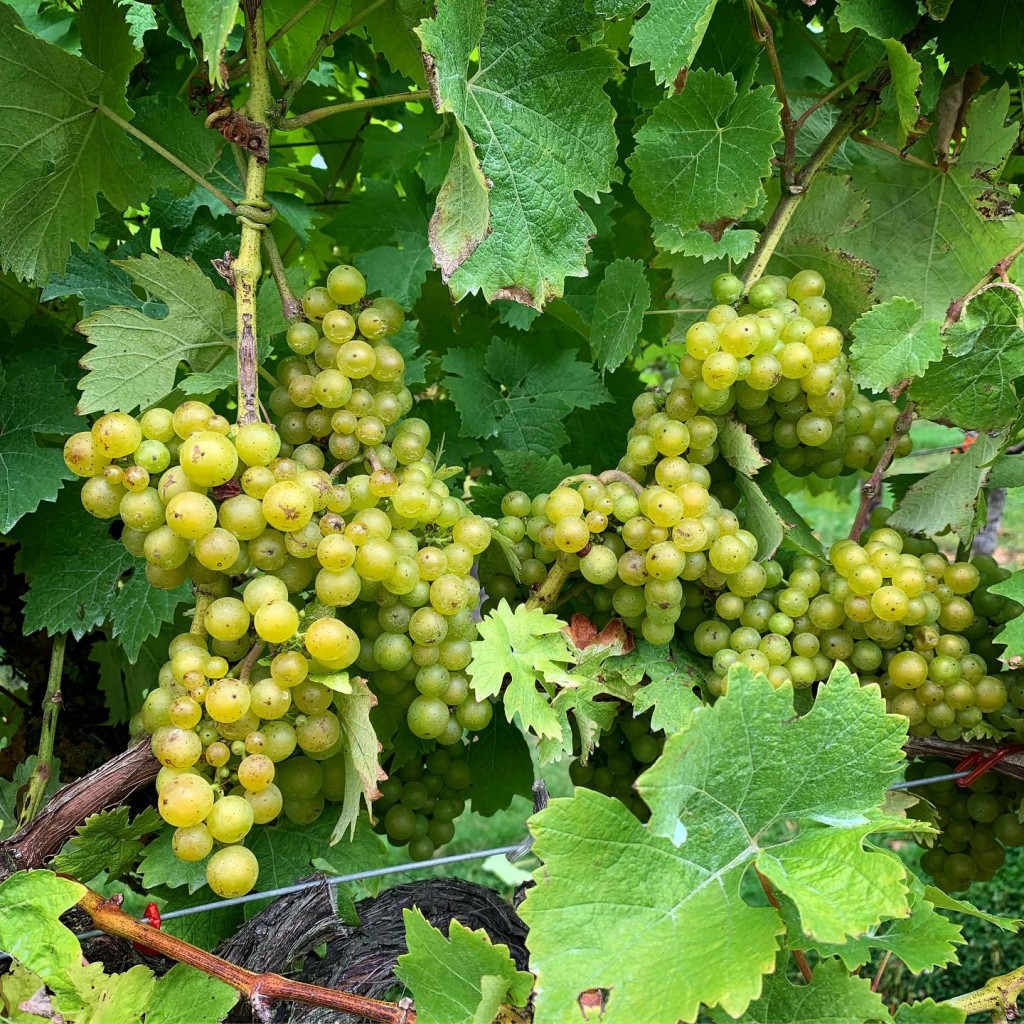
521, 666, 909, 1024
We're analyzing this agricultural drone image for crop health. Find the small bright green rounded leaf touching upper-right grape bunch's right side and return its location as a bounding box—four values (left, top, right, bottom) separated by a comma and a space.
850, 297, 945, 391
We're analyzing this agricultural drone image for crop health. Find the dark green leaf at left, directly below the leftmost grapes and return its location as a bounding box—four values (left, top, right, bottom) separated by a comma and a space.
11, 490, 188, 647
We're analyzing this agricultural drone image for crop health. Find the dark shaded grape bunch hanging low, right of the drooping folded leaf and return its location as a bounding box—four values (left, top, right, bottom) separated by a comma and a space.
374, 743, 472, 860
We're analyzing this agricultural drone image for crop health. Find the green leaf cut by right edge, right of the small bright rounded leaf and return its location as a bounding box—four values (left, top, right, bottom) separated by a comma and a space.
909, 288, 1024, 430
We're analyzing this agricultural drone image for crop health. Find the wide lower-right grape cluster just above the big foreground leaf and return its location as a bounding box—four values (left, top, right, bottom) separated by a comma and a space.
691, 509, 1024, 739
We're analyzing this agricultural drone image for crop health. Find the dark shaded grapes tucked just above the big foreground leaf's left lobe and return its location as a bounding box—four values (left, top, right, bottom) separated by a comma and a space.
569, 711, 665, 821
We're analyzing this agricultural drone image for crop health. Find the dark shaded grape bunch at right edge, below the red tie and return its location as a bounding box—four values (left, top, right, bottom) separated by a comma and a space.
906, 761, 1024, 893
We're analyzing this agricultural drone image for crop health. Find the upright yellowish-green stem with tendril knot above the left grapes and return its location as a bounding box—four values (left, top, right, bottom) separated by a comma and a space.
231, 0, 284, 427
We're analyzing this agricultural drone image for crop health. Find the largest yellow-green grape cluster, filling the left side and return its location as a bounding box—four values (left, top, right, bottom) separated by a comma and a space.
65, 267, 493, 896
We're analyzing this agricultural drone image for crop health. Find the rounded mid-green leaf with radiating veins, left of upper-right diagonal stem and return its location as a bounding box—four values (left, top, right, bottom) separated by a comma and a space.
627, 71, 782, 237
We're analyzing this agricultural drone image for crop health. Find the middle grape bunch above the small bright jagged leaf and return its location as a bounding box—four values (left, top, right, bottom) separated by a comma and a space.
484, 450, 765, 644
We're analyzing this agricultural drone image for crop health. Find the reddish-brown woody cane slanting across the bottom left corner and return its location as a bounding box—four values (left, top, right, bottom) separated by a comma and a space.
78, 889, 416, 1024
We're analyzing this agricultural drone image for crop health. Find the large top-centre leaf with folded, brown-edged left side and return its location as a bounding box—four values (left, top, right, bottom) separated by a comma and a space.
416, 0, 616, 308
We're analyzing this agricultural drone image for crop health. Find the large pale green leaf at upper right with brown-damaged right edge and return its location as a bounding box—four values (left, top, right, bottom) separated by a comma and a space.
836, 86, 1024, 321
